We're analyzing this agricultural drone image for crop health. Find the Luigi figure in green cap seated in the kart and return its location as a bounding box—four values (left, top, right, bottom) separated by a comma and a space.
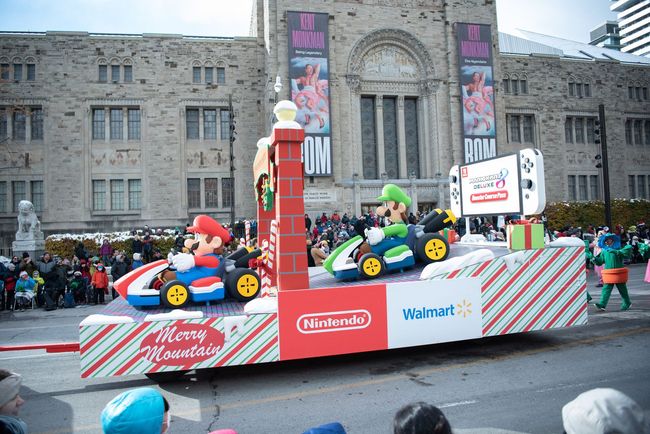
360, 184, 415, 258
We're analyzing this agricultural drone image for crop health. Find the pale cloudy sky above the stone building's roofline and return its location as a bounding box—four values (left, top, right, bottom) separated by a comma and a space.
0, 0, 616, 42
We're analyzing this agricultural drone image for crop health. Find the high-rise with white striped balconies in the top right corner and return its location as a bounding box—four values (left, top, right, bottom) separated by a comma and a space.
609, 0, 650, 57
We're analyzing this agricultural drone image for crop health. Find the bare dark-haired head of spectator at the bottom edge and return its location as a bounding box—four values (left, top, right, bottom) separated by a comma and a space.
393, 402, 452, 434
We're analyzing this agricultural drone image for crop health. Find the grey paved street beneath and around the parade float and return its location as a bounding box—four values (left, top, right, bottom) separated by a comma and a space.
0, 264, 650, 434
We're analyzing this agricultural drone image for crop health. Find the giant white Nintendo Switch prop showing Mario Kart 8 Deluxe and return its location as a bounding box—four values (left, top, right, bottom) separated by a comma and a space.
449, 149, 546, 217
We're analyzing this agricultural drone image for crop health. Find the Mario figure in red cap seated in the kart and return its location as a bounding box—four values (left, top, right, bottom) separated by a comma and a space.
163, 215, 230, 286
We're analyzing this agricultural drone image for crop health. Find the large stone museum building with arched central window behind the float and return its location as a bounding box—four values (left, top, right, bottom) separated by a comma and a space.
0, 0, 650, 254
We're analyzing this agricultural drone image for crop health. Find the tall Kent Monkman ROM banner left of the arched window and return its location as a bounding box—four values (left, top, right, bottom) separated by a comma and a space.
287, 11, 332, 176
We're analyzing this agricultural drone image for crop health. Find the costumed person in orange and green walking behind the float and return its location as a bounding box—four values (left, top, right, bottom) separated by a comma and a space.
587, 234, 632, 311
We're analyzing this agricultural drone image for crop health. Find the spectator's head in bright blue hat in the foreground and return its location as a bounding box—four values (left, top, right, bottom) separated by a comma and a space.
101, 387, 170, 434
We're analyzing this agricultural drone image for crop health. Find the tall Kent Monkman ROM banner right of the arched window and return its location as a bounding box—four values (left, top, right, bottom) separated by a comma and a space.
456, 23, 497, 163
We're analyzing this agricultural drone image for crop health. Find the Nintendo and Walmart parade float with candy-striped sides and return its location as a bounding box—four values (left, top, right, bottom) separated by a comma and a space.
80, 101, 587, 377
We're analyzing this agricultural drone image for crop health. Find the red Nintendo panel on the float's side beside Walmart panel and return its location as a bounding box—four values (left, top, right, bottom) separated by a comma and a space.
278, 284, 388, 360
